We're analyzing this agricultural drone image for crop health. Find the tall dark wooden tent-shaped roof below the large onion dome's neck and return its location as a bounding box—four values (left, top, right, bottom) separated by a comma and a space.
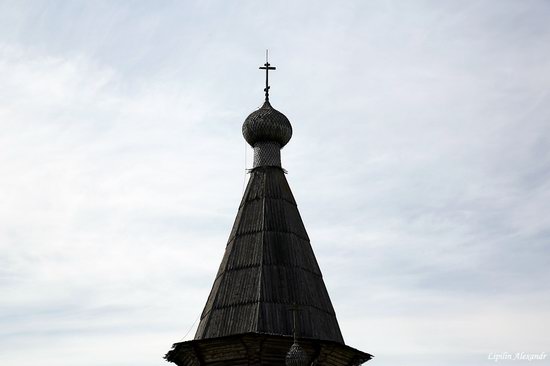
195, 166, 344, 344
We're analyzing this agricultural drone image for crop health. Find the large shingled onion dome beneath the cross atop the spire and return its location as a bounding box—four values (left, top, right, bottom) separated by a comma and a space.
243, 100, 292, 147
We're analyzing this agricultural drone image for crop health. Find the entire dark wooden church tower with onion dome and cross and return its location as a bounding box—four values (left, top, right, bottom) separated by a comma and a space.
165, 57, 372, 366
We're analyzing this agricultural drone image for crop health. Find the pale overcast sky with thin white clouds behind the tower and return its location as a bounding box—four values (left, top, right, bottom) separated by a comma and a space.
0, 0, 550, 366
